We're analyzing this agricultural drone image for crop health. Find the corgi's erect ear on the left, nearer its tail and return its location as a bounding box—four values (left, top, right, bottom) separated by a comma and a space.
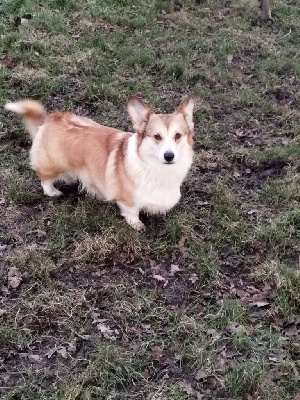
127, 96, 153, 135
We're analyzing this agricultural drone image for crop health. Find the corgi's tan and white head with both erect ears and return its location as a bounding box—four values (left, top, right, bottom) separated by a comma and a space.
128, 95, 195, 164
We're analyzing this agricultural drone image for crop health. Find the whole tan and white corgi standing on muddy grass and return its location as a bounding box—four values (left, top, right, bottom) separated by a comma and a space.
5, 95, 194, 231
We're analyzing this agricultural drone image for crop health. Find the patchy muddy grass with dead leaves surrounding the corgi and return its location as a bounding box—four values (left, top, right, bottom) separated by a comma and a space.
0, 0, 300, 400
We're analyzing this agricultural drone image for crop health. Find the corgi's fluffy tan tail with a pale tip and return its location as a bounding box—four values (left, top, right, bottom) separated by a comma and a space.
4, 100, 47, 139
